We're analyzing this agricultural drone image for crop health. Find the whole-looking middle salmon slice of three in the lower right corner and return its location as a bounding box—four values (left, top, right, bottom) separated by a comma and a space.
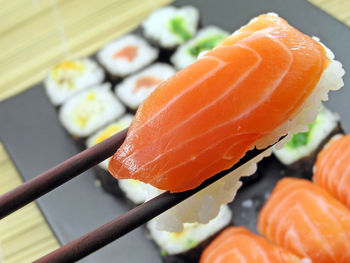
258, 178, 350, 263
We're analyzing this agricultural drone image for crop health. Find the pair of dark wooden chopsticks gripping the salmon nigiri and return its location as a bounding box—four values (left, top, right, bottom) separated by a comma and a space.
0, 129, 280, 263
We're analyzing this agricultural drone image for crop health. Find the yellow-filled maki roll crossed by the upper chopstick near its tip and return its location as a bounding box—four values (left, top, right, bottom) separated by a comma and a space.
86, 114, 134, 197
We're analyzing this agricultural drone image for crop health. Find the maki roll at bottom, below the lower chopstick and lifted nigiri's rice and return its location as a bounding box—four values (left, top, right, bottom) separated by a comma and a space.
146, 205, 232, 263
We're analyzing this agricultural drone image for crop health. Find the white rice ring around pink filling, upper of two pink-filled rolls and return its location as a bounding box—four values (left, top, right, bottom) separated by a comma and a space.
97, 34, 159, 77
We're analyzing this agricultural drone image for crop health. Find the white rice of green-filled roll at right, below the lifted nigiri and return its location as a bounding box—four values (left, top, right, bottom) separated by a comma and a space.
273, 107, 340, 165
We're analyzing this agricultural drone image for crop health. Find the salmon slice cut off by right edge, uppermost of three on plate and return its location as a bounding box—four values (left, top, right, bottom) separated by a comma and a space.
313, 135, 350, 209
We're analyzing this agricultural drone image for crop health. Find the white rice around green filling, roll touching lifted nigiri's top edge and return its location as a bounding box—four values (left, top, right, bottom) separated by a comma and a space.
170, 26, 229, 69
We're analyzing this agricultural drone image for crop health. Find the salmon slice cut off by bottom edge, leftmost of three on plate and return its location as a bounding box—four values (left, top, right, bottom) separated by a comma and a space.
200, 227, 302, 263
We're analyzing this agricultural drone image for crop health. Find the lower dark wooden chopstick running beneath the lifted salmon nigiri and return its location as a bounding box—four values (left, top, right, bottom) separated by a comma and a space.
35, 146, 271, 263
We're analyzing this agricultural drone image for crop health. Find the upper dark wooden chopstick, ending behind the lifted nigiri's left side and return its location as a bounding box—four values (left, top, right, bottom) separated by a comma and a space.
0, 129, 127, 219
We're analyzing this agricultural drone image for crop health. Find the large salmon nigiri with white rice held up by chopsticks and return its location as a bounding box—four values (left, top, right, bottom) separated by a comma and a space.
109, 13, 344, 231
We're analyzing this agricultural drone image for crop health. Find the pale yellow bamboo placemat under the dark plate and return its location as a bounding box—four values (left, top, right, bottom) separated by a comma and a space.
0, 0, 350, 263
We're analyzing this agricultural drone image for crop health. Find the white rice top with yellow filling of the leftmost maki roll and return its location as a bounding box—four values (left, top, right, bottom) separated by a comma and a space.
44, 58, 105, 106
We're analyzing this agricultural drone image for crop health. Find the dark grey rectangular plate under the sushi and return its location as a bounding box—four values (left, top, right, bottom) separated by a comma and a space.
0, 0, 350, 263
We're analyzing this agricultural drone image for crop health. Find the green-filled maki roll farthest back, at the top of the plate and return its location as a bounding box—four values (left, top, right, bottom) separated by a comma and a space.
142, 6, 199, 49
